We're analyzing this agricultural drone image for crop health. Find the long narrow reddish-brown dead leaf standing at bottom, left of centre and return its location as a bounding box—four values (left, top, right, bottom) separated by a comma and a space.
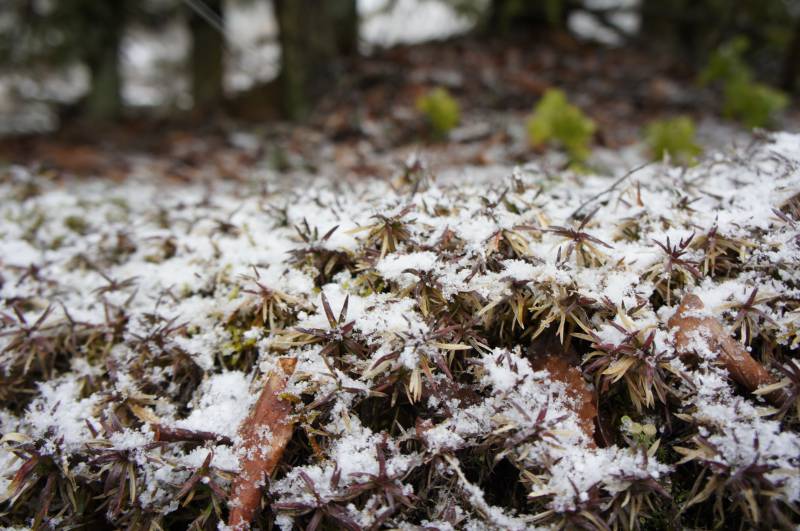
228, 358, 297, 529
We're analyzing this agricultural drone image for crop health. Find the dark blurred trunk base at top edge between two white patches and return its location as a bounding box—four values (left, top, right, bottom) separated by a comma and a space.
484, 0, 574, 36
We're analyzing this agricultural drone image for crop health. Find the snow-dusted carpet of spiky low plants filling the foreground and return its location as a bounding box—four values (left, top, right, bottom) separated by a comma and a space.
0, 134, 800, 529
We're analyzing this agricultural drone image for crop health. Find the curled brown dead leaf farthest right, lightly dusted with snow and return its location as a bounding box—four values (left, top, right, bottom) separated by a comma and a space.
668, 294, 787, 406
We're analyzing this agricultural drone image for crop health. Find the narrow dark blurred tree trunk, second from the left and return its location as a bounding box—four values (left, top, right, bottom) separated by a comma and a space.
189, 0, 225, 110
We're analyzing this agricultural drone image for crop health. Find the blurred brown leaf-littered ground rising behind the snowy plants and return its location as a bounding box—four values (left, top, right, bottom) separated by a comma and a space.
0, 31, 800, 180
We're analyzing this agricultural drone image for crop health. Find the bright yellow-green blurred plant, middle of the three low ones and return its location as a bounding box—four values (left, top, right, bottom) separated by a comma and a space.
527, 89, 597, 162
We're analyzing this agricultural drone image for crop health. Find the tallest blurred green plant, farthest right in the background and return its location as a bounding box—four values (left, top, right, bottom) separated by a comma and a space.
700, 37, 789, 127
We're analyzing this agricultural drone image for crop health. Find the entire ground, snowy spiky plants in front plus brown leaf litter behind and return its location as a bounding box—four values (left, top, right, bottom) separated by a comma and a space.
0, 34, 800, 530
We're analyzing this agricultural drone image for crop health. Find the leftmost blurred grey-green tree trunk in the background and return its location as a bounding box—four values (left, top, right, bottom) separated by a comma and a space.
83, 0, 126, 121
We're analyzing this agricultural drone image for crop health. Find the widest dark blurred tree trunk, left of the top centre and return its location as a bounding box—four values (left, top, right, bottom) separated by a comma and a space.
273, 0, 358, 120
